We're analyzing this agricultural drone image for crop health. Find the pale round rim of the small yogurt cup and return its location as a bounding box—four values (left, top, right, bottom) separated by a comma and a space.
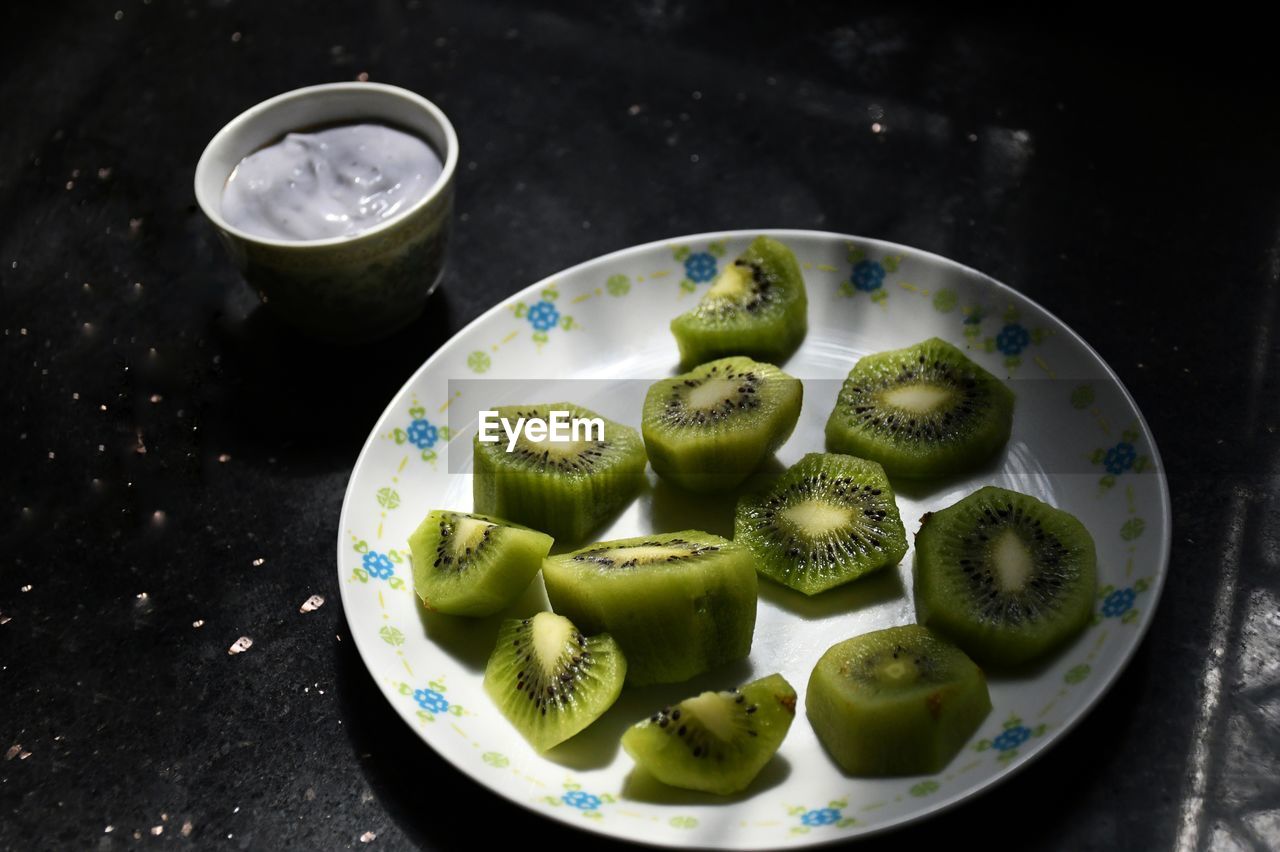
192, 82, 458, 249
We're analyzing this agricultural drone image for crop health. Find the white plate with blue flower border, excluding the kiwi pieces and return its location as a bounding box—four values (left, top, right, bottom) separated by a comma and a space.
338, 230, 1170, 848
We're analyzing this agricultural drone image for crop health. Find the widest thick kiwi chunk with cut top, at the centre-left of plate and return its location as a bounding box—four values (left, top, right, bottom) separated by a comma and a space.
543, 530, 756, 684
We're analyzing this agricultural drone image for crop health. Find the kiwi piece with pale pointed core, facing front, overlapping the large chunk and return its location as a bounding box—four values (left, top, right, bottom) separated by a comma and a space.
484, 613, 627, 751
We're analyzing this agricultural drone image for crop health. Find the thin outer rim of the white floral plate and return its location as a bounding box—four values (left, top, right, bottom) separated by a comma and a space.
335, 228, 1172, 849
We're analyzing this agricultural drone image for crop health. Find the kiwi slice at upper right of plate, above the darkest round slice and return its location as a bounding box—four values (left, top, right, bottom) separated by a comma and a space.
827, 338, 1014, 478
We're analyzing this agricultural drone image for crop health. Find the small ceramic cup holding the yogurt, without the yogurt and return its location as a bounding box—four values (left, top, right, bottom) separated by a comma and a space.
196, 83, 458, 343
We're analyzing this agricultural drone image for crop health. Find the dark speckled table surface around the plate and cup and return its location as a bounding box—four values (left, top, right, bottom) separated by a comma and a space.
0, 0, 1280, 849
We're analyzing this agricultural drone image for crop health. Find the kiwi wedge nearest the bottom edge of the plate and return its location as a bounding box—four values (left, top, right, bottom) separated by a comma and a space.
622, 674, 796, 796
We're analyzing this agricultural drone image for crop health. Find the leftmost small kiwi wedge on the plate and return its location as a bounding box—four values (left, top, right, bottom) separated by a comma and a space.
408, 509, 552, 615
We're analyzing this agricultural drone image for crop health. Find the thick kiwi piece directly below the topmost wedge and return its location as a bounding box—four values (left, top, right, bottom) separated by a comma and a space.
640, 357, 804, 491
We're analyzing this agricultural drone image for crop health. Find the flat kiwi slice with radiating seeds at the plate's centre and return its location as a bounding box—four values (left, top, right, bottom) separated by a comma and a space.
733, 453, 906, 595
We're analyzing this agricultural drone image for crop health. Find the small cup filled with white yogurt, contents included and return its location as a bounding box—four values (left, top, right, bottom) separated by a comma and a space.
195, 83, 458, 343
